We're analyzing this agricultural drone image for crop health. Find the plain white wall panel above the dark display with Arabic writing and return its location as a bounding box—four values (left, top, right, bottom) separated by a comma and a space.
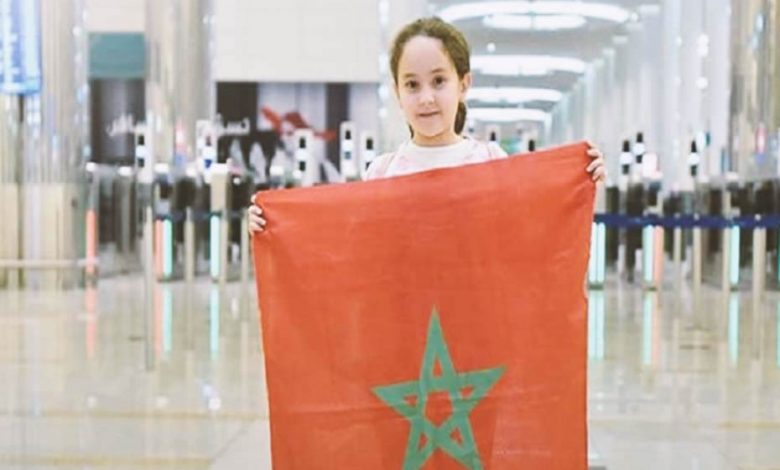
214, 0, 379, 83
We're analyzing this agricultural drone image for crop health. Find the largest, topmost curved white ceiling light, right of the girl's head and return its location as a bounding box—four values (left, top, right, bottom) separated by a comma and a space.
438, 1, 631, 23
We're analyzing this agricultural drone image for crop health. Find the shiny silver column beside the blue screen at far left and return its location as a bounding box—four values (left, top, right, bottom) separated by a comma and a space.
20, 0, 89, 289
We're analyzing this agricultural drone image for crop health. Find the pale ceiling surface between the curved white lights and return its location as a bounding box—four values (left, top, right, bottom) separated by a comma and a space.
428, 0, 660, 115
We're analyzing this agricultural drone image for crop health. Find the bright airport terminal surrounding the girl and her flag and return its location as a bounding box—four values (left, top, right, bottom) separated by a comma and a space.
0, 0, 780, 470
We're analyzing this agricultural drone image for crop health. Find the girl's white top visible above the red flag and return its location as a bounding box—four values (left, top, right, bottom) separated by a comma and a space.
366, 137, 507, 180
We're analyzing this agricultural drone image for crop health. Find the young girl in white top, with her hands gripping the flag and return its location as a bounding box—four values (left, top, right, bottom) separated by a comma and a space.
253, 18, 605, 232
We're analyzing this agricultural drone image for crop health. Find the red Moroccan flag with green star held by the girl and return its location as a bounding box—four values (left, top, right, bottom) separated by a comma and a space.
253, 144, 594, 470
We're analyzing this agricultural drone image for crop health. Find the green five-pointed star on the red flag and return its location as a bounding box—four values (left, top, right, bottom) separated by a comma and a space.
373, 308, 504, 470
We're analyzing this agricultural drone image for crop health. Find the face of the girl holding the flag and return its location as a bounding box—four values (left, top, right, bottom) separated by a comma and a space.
396, 36, 471, 146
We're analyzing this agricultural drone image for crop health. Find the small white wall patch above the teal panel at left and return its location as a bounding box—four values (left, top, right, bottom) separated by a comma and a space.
85, 0, 146, 33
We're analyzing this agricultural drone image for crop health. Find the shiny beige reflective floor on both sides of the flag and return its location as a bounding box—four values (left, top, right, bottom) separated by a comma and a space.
0, 278, 780, 470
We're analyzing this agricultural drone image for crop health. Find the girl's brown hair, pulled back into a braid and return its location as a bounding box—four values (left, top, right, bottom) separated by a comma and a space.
390, 16, 471, 135
